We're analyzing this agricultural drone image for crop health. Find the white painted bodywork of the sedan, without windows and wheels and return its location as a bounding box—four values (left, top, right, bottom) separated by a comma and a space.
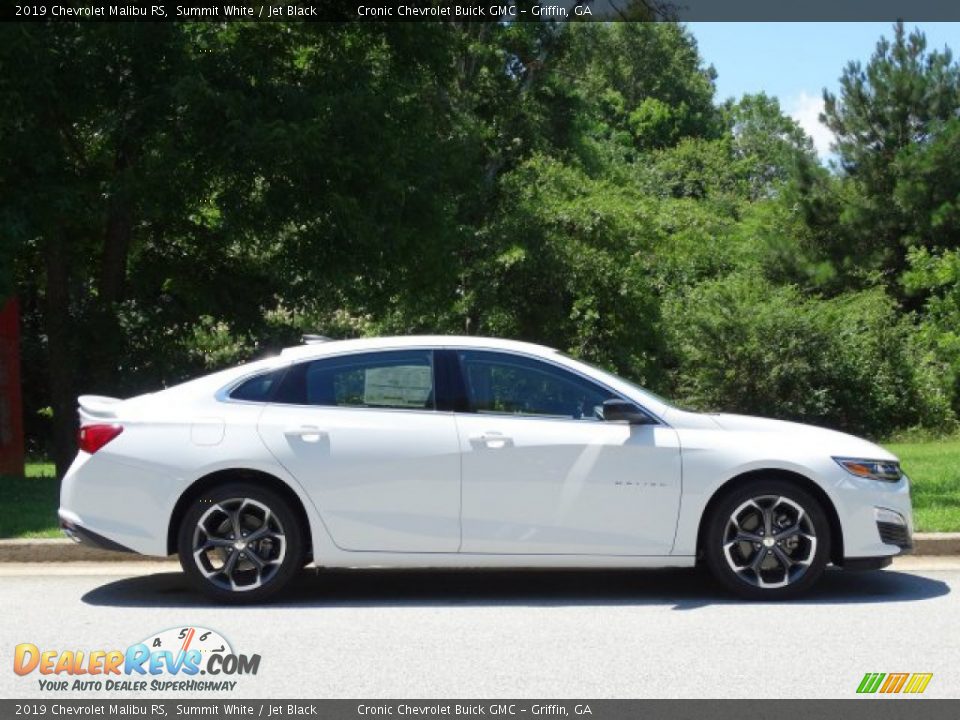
60, 336, 912, 567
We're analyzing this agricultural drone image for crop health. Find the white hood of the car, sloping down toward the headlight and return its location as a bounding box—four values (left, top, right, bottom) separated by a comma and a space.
664, 411, 897, 460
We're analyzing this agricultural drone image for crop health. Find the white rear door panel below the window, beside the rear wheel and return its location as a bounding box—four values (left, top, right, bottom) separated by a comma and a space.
259, 405, 460, 553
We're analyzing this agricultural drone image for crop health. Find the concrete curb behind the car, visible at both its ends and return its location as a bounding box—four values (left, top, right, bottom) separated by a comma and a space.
0, 533, 960, 563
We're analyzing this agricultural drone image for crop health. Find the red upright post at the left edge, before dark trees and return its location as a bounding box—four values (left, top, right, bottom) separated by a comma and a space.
0, 297, 23, 475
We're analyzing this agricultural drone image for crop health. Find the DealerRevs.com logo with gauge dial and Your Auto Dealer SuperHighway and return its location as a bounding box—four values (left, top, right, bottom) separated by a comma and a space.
13, 626, 260, 692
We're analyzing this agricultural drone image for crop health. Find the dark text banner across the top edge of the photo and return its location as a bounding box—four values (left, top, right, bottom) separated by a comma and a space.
0, 0, 960, 22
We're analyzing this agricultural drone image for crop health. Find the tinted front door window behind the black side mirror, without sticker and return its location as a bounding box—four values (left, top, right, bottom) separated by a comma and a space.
459, 350, 616, 420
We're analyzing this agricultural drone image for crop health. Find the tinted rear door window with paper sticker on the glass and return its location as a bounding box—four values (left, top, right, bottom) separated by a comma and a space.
275, 350, 434, 410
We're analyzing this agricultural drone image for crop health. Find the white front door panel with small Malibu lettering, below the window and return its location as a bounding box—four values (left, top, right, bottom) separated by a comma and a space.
457, 420, 681, 555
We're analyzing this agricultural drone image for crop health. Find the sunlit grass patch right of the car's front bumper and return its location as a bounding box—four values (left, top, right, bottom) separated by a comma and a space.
885, 438, 960, 532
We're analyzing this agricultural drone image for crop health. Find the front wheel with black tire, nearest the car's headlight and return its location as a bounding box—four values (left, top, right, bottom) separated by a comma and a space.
703, 478, 830, 600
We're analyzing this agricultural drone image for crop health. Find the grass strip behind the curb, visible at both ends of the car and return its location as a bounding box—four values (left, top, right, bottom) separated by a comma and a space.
0, 438, 960, 538
